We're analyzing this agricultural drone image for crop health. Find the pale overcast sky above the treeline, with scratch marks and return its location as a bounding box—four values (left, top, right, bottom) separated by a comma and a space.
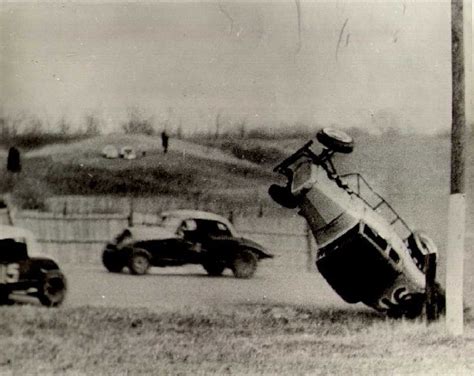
0, 0, 472, 132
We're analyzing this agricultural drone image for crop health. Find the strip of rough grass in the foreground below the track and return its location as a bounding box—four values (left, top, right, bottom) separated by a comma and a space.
0, 305, 474, 375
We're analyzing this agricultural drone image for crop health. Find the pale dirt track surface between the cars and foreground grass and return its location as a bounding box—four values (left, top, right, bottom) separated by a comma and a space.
33, 262, 367, 311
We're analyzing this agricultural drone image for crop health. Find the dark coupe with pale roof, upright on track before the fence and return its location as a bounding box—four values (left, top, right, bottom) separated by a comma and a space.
102, 210, 273, 278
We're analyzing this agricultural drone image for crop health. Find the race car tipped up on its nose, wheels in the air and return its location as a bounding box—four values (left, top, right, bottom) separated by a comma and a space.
269, 128, 444, 318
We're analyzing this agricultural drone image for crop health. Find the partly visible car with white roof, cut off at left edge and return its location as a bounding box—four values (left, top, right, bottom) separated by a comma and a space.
0, 225, 66, 307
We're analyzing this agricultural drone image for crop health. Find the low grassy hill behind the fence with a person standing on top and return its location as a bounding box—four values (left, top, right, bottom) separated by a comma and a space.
1, 134, 280, 209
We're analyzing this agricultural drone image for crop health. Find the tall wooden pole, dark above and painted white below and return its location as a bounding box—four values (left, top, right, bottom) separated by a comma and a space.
446, 0, 466, 335
